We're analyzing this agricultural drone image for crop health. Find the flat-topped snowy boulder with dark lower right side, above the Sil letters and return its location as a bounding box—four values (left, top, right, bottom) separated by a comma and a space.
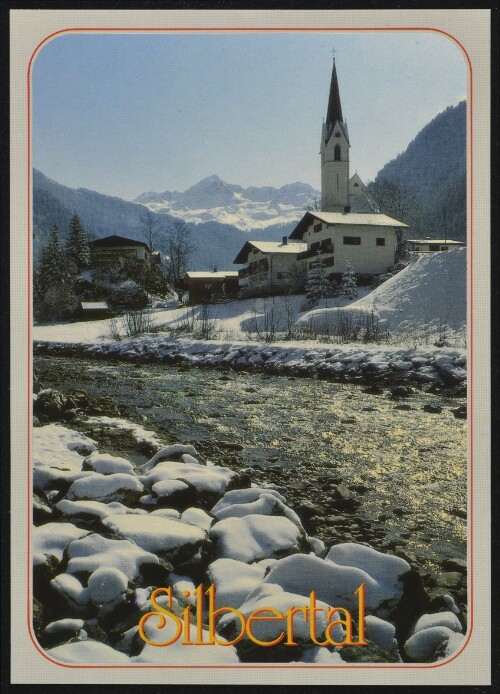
103, 515, 207, 565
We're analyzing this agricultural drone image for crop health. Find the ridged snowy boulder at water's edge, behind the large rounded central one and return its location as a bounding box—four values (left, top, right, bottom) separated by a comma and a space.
211, 487, 302, 526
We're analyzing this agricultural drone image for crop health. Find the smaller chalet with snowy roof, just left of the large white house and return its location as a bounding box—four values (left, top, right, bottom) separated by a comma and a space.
233, 236, 307, 293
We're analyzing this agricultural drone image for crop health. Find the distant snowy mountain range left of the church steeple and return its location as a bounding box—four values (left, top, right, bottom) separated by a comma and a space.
133, 175, 320, 231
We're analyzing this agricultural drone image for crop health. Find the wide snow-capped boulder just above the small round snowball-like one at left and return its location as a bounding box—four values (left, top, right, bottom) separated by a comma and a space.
66, 533, 169, 585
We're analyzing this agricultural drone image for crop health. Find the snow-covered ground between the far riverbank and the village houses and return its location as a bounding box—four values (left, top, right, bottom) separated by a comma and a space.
33, 249, 466, 347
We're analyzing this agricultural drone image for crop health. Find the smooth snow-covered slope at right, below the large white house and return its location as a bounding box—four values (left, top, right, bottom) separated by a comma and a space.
298, 248, 467, 345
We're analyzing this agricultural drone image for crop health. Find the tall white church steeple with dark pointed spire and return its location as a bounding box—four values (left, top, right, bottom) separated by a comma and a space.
321, 57, 350, 212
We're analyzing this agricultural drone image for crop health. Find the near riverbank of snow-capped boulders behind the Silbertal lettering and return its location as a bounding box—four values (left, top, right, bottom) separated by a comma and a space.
33, 414, 465, 666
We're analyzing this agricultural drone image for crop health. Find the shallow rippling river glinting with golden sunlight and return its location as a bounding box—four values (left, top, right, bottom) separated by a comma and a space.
34, 356, 467, 596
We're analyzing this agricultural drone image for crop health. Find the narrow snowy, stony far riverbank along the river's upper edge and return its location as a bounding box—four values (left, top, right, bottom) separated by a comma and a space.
34, 334, 467, 387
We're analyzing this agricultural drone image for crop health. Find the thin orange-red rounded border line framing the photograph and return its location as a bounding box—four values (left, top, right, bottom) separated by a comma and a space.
27, 26, 474, 670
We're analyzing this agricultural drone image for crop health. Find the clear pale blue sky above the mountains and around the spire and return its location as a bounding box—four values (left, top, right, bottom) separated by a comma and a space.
32, 32, 467, 199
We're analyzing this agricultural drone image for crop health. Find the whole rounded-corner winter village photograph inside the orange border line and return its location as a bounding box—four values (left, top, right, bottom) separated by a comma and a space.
31, 32, 470, 667
